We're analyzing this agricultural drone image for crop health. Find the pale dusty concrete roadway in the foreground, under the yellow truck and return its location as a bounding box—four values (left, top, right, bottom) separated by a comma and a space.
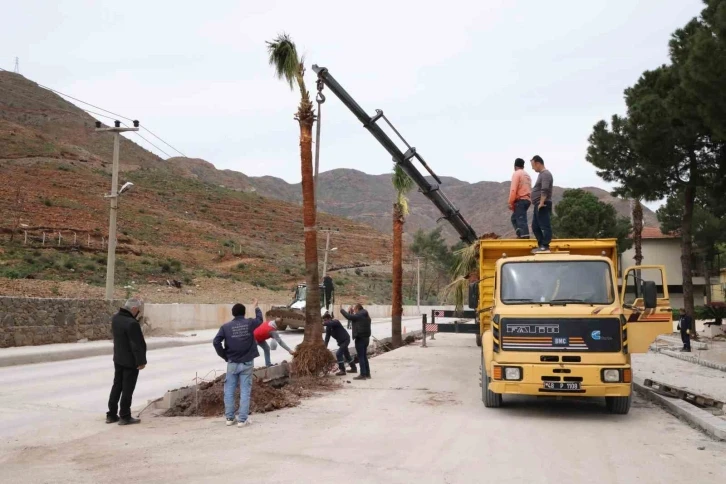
0, 335, 726, 484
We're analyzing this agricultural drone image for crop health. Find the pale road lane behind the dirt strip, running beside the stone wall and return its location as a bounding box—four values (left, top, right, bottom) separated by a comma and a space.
0, 319, 421, 442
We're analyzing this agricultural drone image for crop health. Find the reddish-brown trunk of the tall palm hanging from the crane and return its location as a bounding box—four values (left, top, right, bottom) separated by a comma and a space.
300, 118, 323, 343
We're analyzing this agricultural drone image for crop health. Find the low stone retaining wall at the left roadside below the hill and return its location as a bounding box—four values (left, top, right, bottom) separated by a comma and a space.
0, 297, 123, 348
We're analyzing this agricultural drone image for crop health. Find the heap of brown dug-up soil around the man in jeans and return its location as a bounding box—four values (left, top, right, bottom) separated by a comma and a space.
164, 375, 342, 417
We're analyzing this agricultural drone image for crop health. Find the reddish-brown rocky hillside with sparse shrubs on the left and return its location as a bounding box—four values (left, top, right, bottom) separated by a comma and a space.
0, 72, 398, 300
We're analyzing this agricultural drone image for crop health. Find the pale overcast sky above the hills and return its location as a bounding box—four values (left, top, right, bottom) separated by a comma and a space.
0, 0, 702, 206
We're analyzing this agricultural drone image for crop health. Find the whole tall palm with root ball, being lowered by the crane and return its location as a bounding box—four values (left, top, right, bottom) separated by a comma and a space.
267, 34, 335, 376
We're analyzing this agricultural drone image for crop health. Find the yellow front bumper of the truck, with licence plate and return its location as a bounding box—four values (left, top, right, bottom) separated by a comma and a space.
489, 363, 632, 397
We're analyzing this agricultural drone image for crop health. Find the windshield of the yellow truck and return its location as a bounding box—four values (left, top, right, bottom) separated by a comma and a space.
501, 261, 614, 304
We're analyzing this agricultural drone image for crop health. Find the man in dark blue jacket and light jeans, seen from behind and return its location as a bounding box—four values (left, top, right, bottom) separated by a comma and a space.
213, 299, 262, 427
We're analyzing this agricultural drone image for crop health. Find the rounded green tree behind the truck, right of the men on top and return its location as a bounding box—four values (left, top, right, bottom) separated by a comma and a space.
552, 188, 633, 254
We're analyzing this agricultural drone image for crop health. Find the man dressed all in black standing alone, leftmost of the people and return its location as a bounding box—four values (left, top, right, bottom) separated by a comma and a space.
106, 299, 146, 425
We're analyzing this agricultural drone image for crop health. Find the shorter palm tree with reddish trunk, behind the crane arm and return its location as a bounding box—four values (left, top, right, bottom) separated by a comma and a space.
391, 163, 413, 348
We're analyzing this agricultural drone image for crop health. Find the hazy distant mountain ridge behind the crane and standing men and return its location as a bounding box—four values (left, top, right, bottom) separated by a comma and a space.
168, 158, 658, 242
